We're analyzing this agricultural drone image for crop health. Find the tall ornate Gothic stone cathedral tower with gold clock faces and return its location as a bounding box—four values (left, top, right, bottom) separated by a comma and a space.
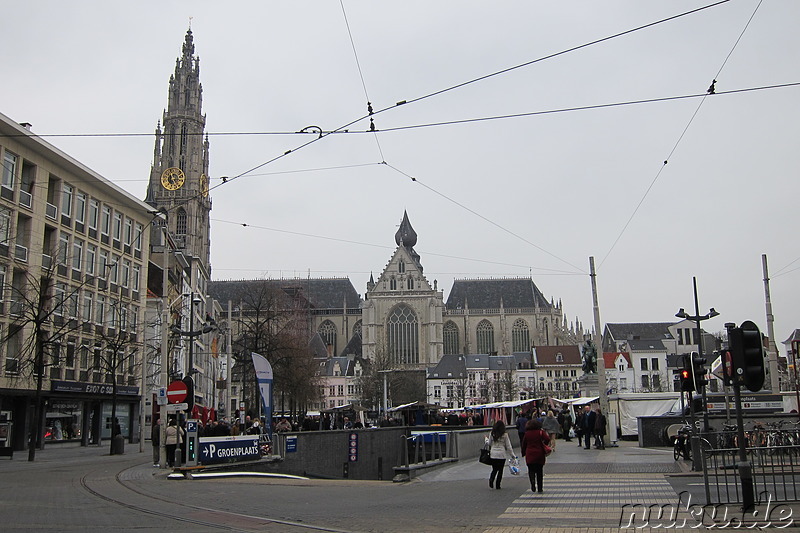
146, 29, 211, 275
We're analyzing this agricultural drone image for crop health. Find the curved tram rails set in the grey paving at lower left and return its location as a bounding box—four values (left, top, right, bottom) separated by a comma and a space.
80, 462, 355, 533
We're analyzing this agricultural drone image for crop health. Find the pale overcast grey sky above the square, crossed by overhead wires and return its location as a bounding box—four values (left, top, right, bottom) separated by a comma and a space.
0, 0, 800, 350
